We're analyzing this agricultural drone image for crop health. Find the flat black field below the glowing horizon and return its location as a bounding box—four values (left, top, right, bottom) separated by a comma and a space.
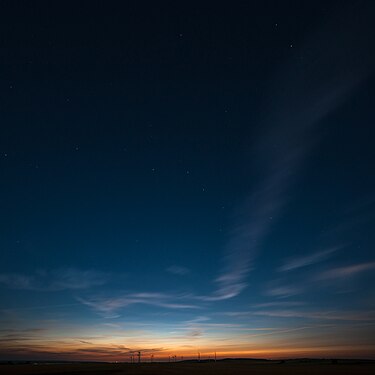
0, 361, 375, 375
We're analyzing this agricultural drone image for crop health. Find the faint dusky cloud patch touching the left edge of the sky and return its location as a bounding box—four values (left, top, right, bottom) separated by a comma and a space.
0, 268, 109, 292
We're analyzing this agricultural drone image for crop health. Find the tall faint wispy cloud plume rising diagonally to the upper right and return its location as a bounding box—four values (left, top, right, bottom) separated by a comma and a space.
205, 3, 374, 301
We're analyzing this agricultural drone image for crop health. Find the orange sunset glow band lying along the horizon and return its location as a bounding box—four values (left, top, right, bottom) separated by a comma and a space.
6, 341, 375, 362
